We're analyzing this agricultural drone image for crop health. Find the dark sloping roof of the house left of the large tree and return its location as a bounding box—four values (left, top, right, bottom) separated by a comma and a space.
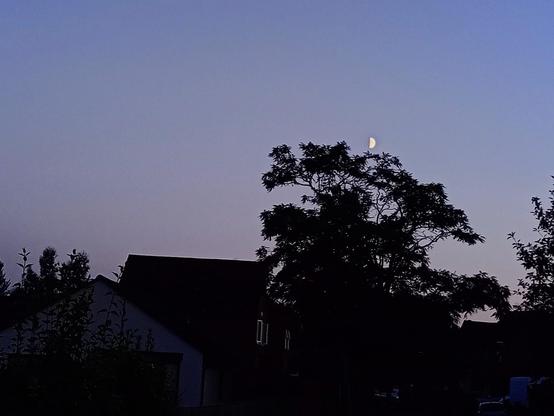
120, 254, 265, 361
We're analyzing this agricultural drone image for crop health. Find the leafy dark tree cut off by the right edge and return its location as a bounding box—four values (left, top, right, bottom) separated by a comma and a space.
509, 180, 554, 314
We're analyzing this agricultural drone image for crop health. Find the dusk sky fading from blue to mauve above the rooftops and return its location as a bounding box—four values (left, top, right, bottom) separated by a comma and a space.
0, 0, 554, 316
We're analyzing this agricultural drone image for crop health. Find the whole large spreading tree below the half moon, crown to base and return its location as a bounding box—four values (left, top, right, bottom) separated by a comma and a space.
257, 142, 510, 414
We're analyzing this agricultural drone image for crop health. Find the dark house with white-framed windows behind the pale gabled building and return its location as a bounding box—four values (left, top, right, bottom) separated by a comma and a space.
120, 255, 297, 404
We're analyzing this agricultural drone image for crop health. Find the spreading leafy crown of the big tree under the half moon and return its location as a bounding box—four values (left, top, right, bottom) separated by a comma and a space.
258, 142, 510, 323
